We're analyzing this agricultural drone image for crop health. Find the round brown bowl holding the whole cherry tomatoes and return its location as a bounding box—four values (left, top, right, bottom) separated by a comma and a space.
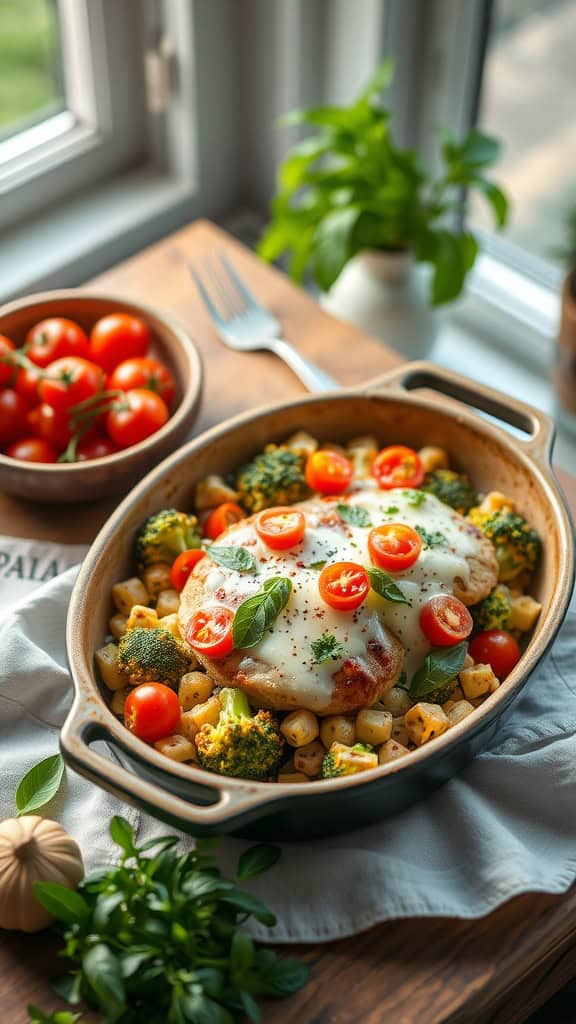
0, 289, 203, 503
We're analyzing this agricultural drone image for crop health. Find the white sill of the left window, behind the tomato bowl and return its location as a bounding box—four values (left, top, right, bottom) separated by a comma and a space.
0, 169, 201, 302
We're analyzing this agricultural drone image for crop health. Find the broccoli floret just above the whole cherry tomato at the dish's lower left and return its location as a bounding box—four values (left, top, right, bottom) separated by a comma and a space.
118, 626, 194, 686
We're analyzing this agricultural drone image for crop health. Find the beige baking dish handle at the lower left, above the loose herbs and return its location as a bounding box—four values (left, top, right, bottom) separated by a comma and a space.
60, 696, 271, 835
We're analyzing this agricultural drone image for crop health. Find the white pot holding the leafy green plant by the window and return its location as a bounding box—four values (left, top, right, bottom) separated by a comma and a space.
321, 250, 439, 359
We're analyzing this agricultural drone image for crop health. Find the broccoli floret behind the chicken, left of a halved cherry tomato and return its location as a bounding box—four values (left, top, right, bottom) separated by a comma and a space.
236, 444, 310, 512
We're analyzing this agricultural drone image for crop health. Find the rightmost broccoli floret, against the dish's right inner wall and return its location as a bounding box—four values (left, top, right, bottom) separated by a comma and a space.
468, 508, 541, 583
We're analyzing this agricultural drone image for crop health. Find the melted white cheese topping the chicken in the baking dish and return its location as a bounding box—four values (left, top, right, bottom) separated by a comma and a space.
205, 481, 478, 709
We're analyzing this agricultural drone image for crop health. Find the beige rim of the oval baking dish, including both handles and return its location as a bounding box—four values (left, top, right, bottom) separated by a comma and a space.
61, 362, 574, 830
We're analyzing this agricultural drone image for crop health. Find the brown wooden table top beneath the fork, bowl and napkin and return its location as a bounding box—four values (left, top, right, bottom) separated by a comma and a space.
0, 221, 576, 1024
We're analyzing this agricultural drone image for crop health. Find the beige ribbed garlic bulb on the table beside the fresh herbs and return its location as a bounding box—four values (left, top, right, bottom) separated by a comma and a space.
0, 814, 84, 932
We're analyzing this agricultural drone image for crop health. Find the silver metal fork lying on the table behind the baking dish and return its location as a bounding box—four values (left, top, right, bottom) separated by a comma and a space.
189, 252, 339, 391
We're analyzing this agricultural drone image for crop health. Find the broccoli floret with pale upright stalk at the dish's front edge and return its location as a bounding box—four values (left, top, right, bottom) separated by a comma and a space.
195, 688, 284, 778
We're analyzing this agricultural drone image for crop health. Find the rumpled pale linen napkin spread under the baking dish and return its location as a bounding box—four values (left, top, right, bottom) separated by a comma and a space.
0, 569, 576, 943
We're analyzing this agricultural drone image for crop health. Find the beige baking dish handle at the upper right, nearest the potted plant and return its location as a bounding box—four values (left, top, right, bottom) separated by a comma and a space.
366, 361, 556, 465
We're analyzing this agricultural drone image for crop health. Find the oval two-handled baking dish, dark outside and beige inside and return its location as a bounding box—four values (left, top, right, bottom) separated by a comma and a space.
60, 362, 574, 839
